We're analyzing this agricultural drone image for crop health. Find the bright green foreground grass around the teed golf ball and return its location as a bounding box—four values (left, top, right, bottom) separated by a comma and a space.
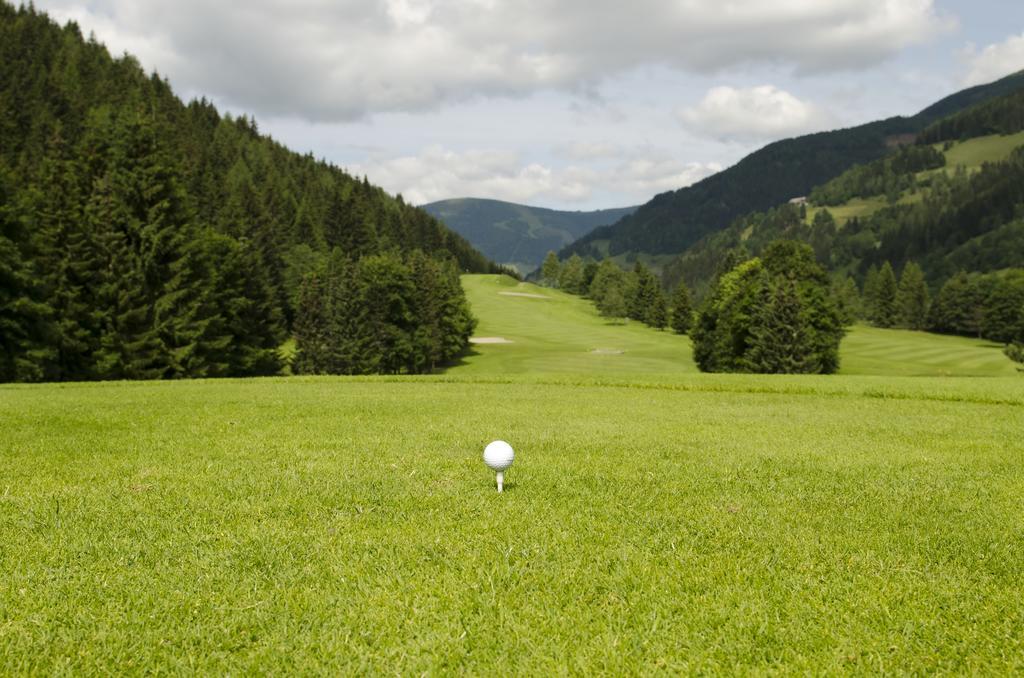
0, 375, 1024, 675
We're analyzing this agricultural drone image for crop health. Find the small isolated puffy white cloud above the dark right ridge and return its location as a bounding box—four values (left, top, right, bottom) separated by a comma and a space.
679, 85, 831, 141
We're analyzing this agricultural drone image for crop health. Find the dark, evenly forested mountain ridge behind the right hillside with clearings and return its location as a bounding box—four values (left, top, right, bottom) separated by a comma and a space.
560, 72, 1024, 266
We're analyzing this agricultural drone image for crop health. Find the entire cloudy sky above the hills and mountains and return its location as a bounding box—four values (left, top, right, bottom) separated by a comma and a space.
36, 0, 1024, 209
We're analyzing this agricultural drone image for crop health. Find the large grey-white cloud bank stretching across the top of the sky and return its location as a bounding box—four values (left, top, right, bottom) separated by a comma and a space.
39, 0, 950, 121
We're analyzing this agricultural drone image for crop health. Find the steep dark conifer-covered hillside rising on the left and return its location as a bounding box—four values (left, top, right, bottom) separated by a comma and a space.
0, 2, 495, 381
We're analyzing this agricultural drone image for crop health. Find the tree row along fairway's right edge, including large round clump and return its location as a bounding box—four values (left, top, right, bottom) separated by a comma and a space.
541, 241, 845, 374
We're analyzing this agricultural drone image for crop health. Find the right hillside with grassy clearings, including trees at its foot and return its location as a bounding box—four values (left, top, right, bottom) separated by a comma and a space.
665, 86, 1024, 362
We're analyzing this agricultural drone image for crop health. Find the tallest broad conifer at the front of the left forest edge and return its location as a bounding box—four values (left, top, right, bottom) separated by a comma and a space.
85, 109, 209, 379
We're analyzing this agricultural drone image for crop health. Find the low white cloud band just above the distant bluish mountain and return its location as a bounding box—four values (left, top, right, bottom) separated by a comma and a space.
349, 146, 722, 207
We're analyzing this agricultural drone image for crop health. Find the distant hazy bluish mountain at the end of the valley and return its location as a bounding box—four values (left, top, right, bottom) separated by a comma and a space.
423, 198, 636, 273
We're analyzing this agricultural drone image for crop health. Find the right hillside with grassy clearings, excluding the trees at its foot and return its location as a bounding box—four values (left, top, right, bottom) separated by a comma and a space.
665, 85, 1024, 294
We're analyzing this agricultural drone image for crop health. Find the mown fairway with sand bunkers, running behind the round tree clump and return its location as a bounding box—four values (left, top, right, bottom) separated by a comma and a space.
460, 276, 1016, 377
